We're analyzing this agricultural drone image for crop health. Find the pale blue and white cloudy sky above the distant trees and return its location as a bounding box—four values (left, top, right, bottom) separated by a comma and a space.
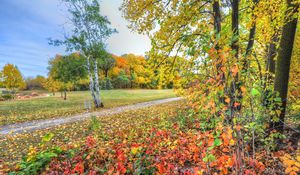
0, 0, 150, 77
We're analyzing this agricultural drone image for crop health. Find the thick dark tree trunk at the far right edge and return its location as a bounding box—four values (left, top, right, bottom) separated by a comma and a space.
270, 0, 298, 132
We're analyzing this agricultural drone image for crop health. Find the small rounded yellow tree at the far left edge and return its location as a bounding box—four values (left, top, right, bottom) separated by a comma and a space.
1, 64, 26, 91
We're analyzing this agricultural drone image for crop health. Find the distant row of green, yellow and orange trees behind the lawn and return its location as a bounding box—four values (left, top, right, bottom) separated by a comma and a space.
0, 53, 180, 93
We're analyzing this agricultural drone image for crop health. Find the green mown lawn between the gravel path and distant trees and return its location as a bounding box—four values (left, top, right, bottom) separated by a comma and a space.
0, 89, 175, 126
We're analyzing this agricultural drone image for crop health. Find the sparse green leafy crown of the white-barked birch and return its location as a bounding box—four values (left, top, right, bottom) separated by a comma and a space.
50, 0, 116, 55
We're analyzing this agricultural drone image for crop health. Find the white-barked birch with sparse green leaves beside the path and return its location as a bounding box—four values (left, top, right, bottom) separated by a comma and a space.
50, 0, 116, 108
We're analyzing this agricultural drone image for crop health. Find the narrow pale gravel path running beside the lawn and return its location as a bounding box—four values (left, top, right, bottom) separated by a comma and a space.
0, 97, 182, 136
